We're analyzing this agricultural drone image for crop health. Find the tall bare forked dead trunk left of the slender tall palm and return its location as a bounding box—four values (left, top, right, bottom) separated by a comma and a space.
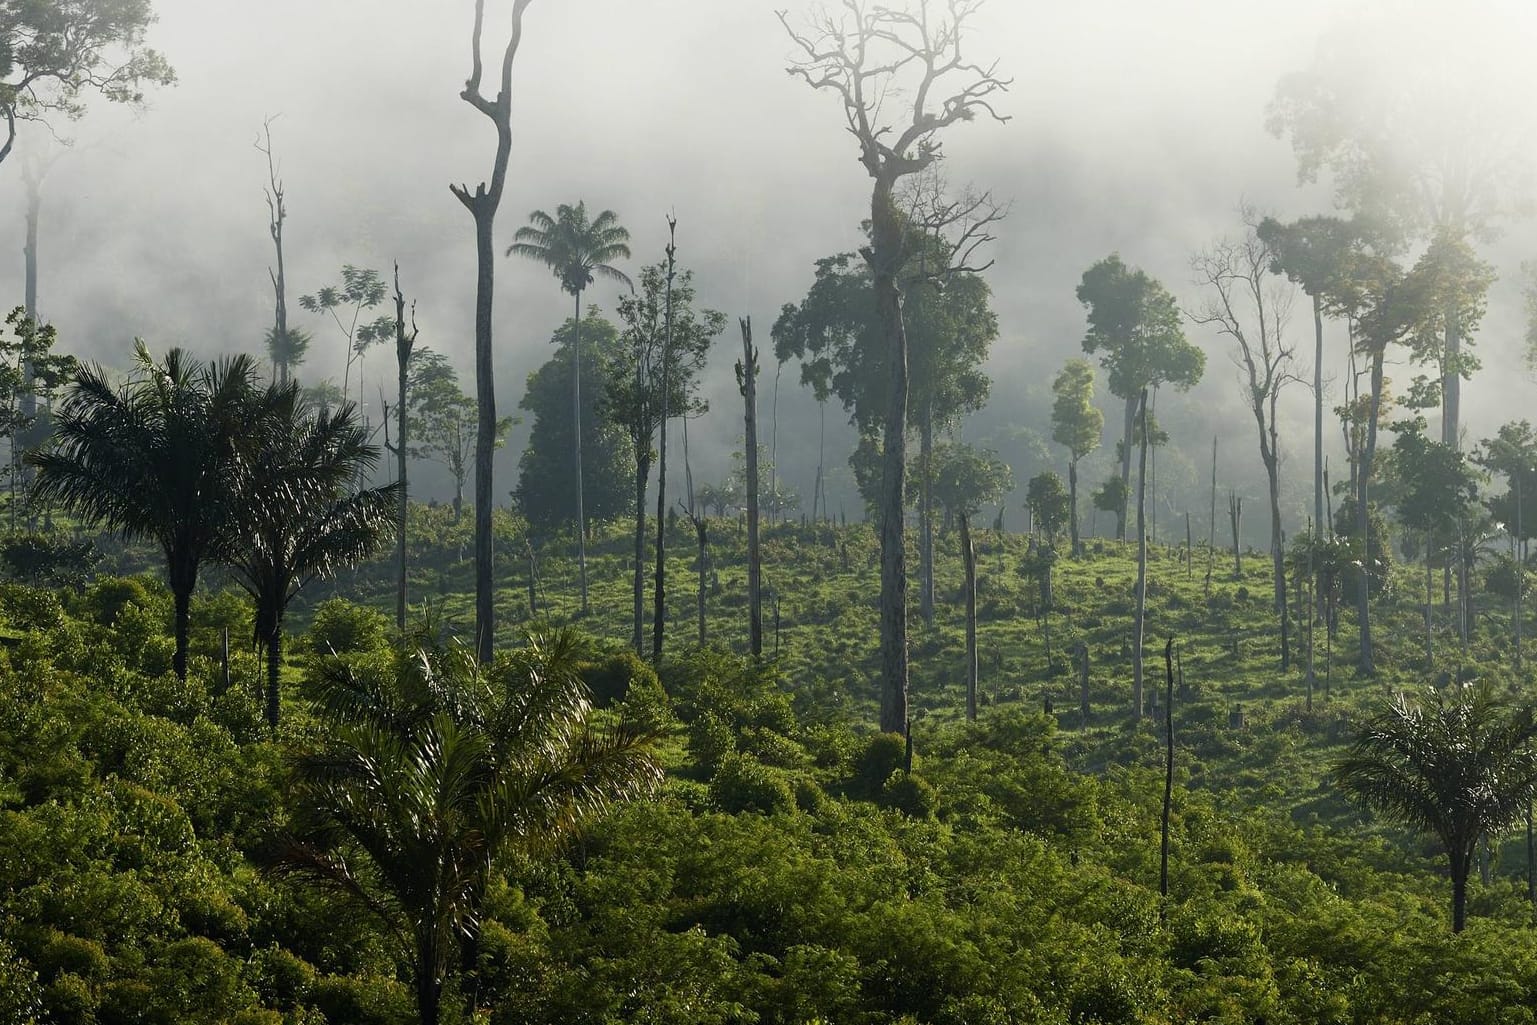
449, 0, 533, 662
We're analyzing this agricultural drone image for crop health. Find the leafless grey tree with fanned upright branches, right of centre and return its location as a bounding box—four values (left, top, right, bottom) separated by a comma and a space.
1190, 207, 1297, 673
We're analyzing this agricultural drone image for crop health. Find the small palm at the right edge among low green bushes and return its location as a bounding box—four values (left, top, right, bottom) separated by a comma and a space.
1334, 684, 1537, 933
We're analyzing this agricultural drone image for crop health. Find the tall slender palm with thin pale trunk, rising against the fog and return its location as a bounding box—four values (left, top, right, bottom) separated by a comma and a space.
507, 203, 635, 615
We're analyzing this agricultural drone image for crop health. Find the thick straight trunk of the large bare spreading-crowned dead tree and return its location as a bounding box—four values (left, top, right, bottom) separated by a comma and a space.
870, 180, 907, 733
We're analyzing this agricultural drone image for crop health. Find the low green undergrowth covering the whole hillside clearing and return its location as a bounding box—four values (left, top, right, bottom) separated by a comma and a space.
9, 507, 1537, 1025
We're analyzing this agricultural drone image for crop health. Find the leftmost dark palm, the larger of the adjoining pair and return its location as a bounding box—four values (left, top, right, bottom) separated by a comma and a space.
28, 343, 260, 679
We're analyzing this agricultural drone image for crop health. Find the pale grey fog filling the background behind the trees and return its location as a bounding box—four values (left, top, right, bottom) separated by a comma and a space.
0, 0, 1537, 536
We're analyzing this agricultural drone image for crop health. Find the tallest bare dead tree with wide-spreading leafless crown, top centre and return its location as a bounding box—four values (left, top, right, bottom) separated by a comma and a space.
780, 0, 1008, 733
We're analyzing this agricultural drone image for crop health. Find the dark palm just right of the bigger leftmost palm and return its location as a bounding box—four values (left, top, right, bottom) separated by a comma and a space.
220, 383, 400, 730
